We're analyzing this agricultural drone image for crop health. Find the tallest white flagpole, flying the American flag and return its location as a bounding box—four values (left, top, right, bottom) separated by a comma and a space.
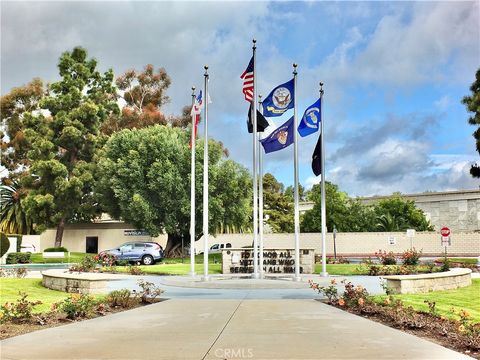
252, 39, 259, 279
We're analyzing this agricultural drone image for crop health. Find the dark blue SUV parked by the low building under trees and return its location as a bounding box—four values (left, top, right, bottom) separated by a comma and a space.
102, 241, 163, 265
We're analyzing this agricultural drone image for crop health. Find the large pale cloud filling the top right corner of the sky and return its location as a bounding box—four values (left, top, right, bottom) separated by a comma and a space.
321, 1, 480, 86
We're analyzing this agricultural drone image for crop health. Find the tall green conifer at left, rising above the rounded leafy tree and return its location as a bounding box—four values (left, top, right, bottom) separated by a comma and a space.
23, 47, 119, 246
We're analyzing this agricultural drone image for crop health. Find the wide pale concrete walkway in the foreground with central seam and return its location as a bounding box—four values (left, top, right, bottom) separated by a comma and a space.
1, 299, 468, 360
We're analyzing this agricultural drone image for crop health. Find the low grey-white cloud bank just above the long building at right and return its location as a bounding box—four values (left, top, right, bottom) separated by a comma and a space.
327, 149, 480, 196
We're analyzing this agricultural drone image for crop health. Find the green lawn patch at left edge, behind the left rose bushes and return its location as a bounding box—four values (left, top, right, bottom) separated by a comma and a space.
0, 278, 68, 312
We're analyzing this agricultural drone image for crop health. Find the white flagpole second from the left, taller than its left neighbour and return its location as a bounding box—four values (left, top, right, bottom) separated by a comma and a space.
203, 65, 209, 281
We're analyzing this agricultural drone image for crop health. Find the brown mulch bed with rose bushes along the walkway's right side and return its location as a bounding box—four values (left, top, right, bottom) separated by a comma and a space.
325, 301, 480, 359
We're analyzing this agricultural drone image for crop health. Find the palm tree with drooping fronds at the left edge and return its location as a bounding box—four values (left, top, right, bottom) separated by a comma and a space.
0, 181, 34, 234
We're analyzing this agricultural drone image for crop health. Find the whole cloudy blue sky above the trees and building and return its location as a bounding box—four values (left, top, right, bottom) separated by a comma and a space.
0, 1, 480, 195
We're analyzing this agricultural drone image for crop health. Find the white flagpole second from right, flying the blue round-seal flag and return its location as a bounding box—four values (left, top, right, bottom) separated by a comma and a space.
293, 64, 300, 281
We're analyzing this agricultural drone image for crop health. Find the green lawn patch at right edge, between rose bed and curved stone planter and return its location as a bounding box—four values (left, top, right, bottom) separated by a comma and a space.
374, 279, 480, 322
